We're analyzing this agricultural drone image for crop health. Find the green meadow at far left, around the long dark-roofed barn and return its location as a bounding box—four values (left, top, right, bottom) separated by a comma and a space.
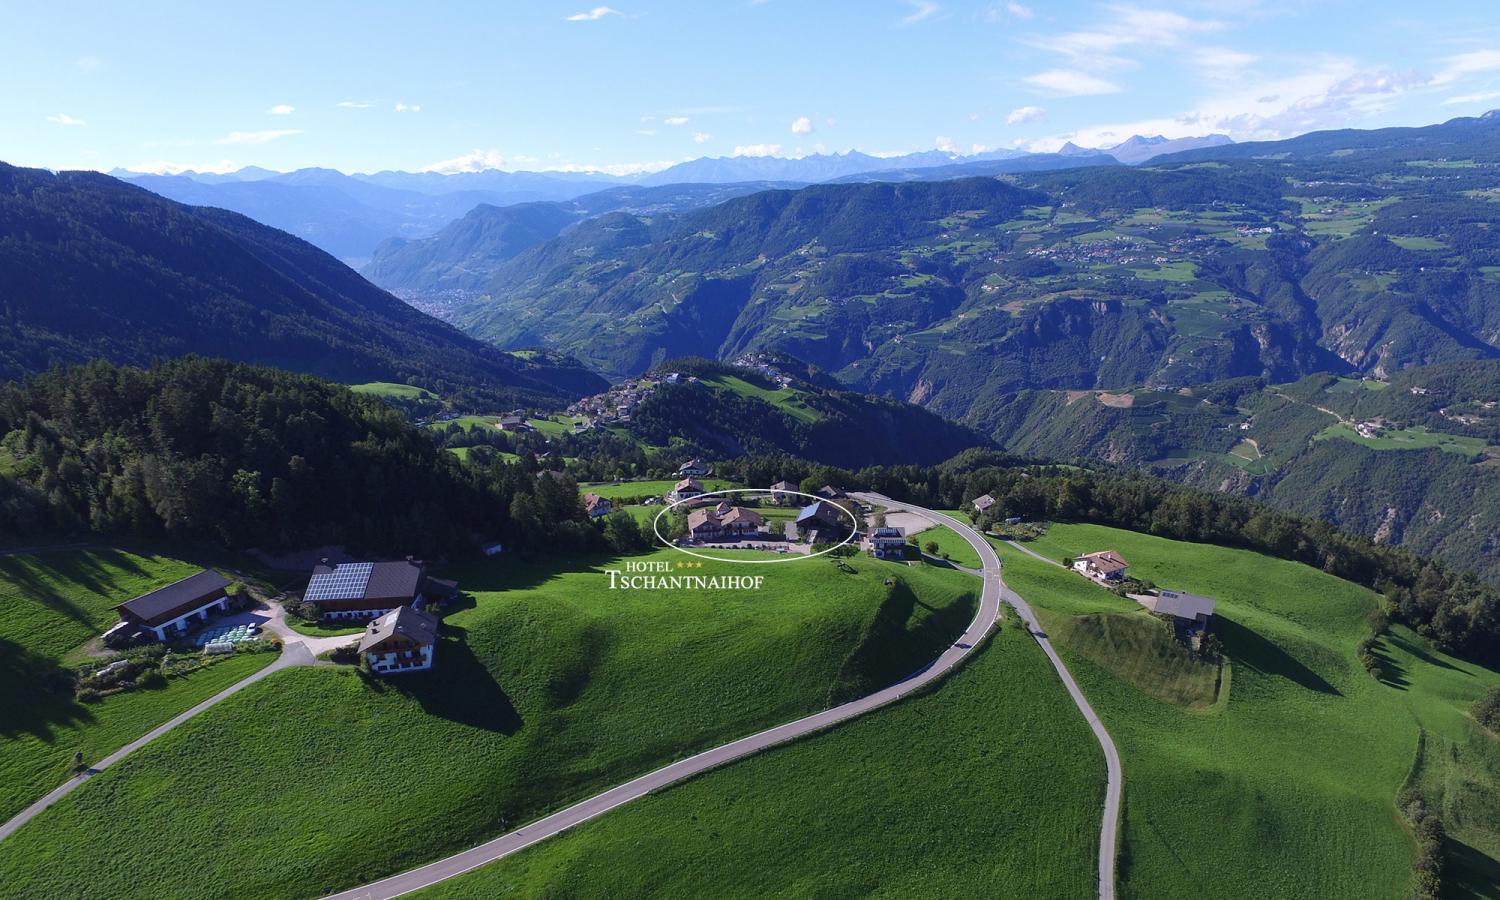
0, 548, 276, 821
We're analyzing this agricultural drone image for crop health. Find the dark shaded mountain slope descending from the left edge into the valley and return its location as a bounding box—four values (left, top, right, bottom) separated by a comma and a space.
0, 164, 603, 402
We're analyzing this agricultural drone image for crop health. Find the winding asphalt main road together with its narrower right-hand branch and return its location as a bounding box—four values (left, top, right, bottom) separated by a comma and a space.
326, 494, 1121, 900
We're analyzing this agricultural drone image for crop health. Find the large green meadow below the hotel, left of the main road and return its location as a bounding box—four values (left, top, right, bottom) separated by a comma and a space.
0, 551, 978, 897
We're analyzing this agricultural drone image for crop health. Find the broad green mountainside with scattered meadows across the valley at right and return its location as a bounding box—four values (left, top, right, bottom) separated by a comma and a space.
458, 111, 1500, 393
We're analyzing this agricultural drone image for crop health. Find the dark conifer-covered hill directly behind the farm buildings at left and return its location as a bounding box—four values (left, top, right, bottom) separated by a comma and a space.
0, 359, 597, 557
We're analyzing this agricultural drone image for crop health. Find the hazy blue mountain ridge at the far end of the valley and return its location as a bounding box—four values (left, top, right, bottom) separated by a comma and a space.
362, 182, 788, 296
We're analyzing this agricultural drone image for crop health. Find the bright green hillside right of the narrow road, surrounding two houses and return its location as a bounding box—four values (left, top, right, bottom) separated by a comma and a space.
999, 525, 1500, 900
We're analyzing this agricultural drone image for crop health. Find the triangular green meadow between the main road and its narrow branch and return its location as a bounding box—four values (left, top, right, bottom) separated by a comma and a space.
419, 620, 1104, 899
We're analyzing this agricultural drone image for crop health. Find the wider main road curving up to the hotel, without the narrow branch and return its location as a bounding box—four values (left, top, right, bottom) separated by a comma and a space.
326, 494, 1008, 900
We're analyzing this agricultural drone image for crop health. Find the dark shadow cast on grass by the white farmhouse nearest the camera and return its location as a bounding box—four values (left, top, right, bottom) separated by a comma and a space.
362, 624, 522, 735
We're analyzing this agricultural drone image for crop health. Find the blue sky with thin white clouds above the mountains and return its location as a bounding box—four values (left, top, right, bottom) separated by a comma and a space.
0, 0, 1500, 173
